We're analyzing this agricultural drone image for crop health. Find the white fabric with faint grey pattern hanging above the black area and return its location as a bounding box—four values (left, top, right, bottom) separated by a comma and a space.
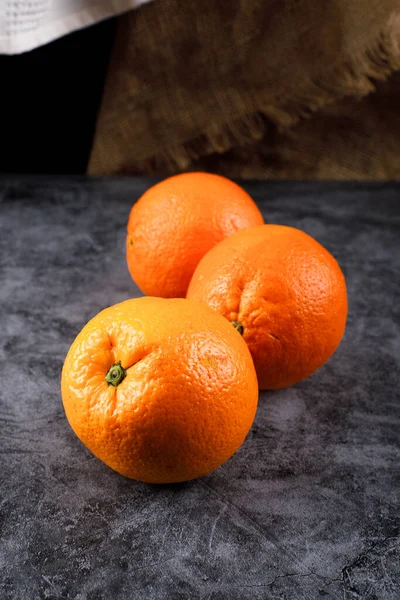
0, 0, 151, 54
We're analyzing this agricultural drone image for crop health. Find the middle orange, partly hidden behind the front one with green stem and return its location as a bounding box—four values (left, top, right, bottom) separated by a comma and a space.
188, 225, 347, 389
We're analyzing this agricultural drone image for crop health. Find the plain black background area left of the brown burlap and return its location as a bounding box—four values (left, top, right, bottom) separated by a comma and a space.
0, 19, 116, 174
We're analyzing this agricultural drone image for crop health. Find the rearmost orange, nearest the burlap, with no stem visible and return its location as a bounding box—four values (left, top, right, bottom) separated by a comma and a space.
126, 173, 264, 298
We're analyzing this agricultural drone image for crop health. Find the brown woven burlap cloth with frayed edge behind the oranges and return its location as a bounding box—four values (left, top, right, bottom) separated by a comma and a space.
88, 0, 400, 179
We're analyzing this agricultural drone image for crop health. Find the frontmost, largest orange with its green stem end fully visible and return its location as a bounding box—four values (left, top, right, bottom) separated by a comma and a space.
61, 297, 258, 483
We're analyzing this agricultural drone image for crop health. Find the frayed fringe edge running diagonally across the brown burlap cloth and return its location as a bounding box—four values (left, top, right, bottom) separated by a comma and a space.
88, 14, 400, 175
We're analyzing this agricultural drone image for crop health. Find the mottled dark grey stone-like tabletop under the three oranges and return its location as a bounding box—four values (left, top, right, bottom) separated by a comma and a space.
0, 178, 400, 600
